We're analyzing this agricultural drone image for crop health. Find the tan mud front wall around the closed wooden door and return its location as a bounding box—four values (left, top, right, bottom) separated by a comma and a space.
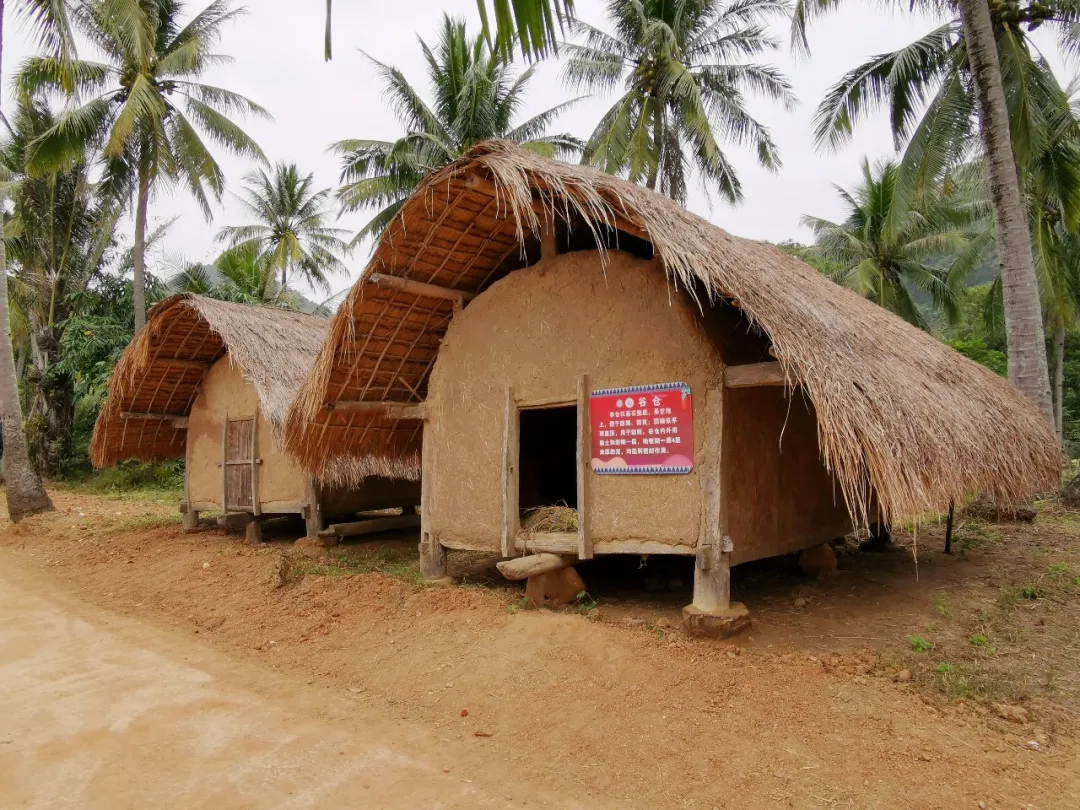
187, 355, 307, 504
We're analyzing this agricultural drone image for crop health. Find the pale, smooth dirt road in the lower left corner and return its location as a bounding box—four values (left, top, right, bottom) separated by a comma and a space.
0, 568, 575, 810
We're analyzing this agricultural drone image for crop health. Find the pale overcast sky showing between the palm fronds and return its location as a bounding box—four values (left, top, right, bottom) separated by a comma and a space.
3, 0, 1068, 298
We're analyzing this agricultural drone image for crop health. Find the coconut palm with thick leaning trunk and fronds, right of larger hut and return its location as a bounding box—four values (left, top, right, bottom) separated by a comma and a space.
793, 0, 1080, 421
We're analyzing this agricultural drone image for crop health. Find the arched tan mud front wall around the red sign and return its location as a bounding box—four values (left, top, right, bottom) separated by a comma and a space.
424, 251, 720, 549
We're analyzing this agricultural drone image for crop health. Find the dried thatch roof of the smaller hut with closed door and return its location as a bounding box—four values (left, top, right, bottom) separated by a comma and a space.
90, 294, 419, 483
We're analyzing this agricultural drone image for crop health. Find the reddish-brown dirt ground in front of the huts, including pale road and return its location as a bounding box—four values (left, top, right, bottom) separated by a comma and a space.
6, 491, 1080, 810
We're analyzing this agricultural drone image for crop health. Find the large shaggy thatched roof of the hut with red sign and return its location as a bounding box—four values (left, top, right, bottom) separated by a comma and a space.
285, 141, 1059, 523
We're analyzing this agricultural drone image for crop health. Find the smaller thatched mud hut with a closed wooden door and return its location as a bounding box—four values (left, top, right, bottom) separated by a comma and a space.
91, 294, 419, 535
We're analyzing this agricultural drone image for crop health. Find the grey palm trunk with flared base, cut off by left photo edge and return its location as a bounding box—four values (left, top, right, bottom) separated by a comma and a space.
0, 0, 53, 523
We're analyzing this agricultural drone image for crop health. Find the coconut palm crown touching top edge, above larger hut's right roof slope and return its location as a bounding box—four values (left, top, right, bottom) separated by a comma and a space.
564, 0, 795, 203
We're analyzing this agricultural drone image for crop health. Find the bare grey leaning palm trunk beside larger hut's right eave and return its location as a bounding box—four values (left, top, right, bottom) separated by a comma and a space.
960, 0, 1054, 424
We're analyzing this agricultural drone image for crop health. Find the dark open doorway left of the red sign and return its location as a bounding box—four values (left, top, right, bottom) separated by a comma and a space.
517, 405, 578, 512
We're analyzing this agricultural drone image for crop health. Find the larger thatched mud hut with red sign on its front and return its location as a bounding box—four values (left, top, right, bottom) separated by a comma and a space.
285, 143, 1059, 635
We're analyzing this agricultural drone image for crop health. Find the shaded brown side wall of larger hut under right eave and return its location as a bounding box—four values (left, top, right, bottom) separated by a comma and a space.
723, 387, 851, 564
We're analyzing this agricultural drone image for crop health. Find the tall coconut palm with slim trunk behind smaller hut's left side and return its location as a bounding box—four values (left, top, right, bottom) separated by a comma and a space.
18, 0, 269, 330
